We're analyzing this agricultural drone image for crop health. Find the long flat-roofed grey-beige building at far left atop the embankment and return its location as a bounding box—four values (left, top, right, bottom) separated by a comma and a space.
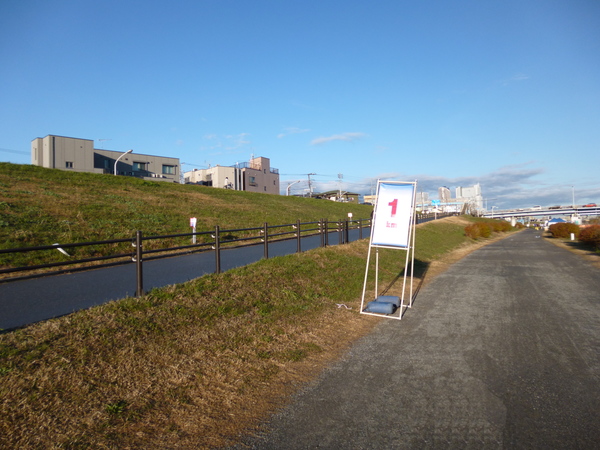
31, 134, 180, 183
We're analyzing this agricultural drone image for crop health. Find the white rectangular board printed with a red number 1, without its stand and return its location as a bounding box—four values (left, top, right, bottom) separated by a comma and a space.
371, 182, 415, 248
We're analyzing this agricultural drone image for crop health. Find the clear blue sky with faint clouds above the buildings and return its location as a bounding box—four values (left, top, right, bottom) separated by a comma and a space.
0, 0, 600, 208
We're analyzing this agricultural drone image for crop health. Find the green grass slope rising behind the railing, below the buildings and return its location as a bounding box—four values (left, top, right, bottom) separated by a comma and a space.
0, 163, 372, 248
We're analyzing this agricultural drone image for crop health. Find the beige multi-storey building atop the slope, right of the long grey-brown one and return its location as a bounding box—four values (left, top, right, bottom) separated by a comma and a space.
184, 156, 279, 194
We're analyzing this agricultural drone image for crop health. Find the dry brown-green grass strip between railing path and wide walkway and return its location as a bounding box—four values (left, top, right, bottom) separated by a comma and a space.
0, 163, 516, 448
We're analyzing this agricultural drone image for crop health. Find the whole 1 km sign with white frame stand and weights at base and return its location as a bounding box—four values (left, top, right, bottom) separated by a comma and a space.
360, 180, 417, 320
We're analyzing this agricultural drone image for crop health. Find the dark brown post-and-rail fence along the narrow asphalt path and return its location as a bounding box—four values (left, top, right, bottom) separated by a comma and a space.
0, 219, 371, 288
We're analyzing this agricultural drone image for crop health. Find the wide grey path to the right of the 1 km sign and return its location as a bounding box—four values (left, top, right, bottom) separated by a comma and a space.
236, 230, 600, 449
